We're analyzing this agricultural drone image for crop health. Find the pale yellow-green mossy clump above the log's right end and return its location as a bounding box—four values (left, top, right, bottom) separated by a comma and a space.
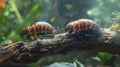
110, 12, 120, 32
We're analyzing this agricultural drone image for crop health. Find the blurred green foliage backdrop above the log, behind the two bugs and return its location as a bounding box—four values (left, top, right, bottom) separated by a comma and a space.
0, 0, 120, 43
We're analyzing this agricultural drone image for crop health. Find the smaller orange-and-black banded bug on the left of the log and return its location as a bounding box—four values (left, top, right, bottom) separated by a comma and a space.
20, 22, 54, 37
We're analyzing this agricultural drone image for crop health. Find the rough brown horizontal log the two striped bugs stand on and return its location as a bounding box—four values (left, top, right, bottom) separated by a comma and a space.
0, 29, 120, 63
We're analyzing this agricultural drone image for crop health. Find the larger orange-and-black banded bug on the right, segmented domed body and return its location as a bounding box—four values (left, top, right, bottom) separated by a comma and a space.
65, 19, 100, 32
